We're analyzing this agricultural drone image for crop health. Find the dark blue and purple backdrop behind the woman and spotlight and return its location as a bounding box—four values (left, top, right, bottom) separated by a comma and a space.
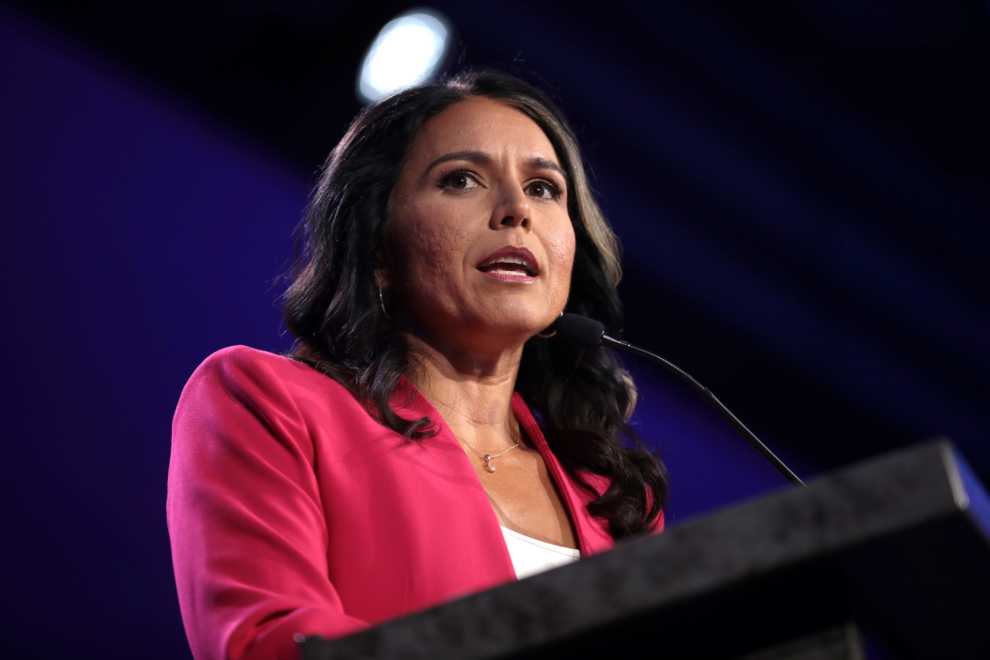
0, 0, 990, 658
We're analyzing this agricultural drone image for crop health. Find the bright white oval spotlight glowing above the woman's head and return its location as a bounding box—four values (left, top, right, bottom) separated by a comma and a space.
358, 9, 450, 101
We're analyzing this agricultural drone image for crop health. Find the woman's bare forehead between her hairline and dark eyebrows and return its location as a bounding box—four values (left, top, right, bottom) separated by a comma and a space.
410, 97, 560, 165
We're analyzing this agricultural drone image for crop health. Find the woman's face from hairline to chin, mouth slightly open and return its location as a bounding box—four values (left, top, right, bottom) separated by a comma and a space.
382, 97, 575, 351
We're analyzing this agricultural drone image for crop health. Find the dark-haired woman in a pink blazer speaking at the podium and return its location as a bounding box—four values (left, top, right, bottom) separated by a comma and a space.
168, 72, 666, 660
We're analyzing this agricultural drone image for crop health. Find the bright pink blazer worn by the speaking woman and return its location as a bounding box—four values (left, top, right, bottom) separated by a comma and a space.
166, 346, 662, 660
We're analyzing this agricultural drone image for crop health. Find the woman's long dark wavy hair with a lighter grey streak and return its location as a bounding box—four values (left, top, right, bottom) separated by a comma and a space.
284, 70, 667, 539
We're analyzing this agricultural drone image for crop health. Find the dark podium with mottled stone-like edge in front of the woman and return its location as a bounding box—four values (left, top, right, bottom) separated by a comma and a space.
300, 442, 990, 660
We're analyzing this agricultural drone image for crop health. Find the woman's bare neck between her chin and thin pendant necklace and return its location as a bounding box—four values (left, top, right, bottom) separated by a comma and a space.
406, 334, 523, 450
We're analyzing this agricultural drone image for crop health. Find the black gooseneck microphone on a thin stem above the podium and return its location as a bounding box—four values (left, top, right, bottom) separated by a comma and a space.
555, 314, 804, 486
